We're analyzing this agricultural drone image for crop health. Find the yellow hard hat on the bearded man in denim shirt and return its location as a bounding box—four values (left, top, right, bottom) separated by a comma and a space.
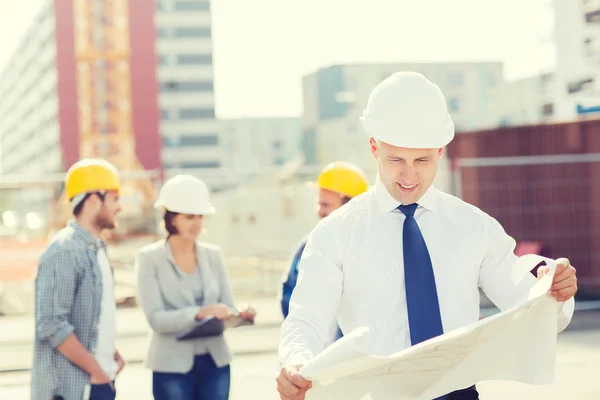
65, 158, 121, 201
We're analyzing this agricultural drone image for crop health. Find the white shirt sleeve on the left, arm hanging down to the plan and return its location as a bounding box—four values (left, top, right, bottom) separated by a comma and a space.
279, 221, 343, 365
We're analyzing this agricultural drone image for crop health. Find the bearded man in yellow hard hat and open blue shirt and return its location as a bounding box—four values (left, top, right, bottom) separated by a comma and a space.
31, 159, 125, 400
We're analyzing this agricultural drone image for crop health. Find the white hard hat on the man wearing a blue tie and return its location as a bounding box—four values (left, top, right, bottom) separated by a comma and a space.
360, 72, 454, 149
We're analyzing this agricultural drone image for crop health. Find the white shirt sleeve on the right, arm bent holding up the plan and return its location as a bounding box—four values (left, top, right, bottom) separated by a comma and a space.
479, 215, 574, 332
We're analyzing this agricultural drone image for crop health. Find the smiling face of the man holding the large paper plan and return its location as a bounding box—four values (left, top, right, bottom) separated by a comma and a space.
370, 138, 442, 204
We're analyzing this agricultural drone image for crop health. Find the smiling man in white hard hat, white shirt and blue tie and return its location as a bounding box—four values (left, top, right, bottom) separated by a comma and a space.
277, 72, 577, 400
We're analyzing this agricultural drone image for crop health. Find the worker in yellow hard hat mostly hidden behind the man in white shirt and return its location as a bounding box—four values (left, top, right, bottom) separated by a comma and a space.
281, 161, 369, 339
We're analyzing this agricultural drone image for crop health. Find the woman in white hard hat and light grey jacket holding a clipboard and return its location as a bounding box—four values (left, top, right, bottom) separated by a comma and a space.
136, 175, 256, 400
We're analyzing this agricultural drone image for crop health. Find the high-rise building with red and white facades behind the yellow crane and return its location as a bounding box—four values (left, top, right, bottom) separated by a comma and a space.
0, 0, 221, 180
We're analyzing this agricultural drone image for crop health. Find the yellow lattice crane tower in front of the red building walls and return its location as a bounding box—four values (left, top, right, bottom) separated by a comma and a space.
52, 0, 156, 236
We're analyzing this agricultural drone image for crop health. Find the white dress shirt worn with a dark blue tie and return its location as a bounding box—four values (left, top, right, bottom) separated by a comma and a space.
279, 180, 573, 364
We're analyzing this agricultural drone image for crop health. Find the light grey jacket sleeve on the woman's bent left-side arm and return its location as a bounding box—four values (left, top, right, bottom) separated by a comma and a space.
135, 253, 200, 334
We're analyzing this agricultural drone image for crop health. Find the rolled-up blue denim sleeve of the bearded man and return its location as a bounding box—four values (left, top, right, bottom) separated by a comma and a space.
35, 248, 78, 348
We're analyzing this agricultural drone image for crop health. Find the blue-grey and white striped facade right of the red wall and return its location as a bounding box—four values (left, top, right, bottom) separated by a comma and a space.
155, 0, 222, 178
